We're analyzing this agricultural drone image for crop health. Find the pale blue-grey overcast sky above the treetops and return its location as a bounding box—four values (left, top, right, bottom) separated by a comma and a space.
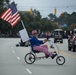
10, 0, 76, 17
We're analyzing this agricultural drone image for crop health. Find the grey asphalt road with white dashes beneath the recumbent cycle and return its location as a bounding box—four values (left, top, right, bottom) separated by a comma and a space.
0, 38, 76, 75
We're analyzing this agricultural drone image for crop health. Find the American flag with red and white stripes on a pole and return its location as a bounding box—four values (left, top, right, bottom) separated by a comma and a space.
0, 2, 21, 27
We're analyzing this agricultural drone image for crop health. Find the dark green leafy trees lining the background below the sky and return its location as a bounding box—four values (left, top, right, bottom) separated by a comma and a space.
0, 0, 76, 33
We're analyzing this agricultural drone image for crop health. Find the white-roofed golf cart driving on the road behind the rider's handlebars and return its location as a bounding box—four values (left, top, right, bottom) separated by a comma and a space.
54, 29, 63, 43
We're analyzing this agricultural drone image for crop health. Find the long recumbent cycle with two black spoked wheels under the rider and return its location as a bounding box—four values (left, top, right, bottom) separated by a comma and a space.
24, 39, 65, 65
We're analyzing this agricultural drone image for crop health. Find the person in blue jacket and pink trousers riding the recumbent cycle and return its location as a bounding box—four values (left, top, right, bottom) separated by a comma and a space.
30, 30, 57, 59
